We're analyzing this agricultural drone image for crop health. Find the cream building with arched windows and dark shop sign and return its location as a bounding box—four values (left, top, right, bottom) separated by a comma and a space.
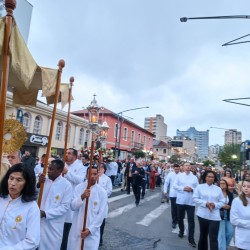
5, 93, 90, 157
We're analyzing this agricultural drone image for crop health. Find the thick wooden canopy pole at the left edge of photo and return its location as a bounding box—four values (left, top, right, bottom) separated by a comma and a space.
0, 0, 16, 173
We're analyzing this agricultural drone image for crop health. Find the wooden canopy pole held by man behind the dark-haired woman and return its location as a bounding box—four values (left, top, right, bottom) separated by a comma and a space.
37, 60, 65, 207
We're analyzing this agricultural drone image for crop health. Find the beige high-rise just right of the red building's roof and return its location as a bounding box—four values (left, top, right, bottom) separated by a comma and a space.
144, 115, 167, 141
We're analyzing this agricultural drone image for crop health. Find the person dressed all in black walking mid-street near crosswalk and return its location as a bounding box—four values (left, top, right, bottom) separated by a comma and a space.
132, 160, 145, 206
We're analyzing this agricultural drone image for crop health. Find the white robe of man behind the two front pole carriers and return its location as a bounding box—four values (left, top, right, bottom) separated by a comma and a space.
64, 160, 86, 223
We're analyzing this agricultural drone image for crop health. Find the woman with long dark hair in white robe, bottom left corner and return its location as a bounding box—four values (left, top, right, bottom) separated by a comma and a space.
0, 163, 40, 250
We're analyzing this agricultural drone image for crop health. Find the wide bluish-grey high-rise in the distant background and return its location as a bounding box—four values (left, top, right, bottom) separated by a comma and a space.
176, 127, 209, 160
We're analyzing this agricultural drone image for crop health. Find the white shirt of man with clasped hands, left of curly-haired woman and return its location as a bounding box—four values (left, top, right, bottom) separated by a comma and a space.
173, 172, 199, 206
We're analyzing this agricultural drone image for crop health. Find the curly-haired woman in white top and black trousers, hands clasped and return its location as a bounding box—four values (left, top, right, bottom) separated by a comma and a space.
193, 170, 225, 250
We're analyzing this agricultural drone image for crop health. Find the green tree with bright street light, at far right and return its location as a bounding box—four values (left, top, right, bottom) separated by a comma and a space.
218, 144, 240, 168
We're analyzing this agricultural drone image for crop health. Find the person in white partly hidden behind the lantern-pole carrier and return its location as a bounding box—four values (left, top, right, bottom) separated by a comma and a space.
98, 163, 113, 246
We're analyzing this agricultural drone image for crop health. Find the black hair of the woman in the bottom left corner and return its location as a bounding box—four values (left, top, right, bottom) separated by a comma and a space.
0, 163, 37, 202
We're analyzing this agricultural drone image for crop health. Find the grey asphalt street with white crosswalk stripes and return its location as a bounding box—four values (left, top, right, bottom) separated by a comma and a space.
99, 187, 234, 250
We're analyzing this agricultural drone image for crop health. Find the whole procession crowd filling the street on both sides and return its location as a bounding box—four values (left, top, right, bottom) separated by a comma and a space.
0, 148, 250, 250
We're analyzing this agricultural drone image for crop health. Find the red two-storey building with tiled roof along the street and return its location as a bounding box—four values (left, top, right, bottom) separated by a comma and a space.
71, 108, 154, 159
